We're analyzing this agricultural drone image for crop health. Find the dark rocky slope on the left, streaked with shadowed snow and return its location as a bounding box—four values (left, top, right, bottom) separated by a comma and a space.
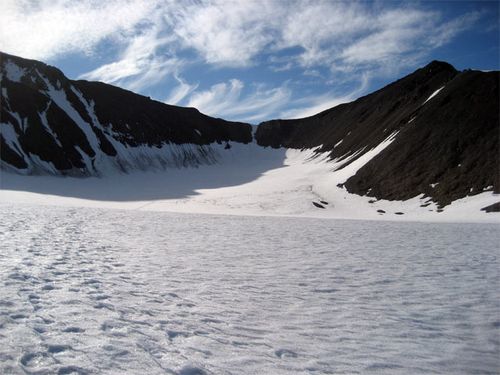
0, 53, 252, 175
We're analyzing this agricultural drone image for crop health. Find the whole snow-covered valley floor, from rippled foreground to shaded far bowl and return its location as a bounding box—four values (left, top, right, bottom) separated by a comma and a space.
0, 143, 500, 375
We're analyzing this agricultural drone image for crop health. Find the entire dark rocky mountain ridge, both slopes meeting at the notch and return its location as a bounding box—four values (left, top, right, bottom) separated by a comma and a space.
0, 53, 500, 212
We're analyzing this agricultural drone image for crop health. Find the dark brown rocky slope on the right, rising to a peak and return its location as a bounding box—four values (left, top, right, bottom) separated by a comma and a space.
256, 61, 500, 206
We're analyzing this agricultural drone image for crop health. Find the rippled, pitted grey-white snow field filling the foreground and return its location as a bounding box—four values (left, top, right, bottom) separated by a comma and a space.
0, 203, 500, 375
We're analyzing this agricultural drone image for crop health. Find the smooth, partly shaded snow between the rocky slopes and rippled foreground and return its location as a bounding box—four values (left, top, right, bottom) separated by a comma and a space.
0, 141, 500, 223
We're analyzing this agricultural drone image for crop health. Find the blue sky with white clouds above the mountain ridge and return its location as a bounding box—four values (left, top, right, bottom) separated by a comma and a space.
0, 0, 500, 124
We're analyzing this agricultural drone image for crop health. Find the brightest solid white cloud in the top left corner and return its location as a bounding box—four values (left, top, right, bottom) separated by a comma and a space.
0, 0, 156, 60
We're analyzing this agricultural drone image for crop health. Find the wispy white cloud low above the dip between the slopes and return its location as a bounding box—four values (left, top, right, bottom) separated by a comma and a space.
188, 79, 291, 122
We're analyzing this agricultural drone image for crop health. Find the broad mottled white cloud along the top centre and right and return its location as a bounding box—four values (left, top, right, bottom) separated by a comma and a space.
161, 0, 477, 72
